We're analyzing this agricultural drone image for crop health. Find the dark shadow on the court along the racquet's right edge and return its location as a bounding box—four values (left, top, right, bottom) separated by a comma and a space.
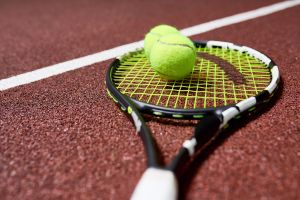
178, 79, 284, 200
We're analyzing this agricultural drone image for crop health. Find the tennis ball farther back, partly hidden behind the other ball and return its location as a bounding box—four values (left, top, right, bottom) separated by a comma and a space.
144, 25, 179, 58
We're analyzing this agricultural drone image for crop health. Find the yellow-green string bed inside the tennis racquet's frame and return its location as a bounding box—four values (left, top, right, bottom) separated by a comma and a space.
112, 47, 271, 109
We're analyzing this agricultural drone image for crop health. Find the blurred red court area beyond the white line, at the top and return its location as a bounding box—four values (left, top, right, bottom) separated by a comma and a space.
0, 0, 276, 78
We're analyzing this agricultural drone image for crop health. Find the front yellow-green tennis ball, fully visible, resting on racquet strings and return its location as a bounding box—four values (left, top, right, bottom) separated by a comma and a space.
150, 34, 196, 80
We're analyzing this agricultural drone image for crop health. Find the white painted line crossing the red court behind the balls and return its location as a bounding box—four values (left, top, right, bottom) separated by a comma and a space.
0, 0, 300, 91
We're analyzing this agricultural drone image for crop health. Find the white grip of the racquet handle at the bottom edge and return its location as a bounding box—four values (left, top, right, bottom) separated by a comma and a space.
130, 168, 178, 200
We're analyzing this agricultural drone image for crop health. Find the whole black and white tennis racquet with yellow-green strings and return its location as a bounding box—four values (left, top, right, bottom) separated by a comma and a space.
106, 41, 280, 200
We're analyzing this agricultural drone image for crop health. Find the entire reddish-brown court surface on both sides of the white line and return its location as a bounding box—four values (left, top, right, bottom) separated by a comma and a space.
0, 0, 300, 200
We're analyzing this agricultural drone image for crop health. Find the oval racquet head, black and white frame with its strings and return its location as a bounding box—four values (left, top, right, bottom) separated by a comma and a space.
106, 41, 279, 119
